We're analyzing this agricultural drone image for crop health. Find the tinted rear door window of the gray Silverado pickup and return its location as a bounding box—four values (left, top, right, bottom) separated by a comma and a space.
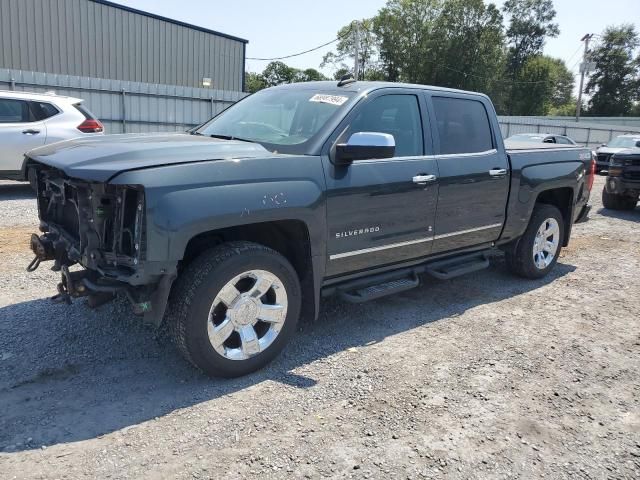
433, 97, 494, 155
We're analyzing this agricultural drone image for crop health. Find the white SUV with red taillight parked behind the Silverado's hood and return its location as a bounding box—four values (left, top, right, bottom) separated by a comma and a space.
0, 90, 104, 180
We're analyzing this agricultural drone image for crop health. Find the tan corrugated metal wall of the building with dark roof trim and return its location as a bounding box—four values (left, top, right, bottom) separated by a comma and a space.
0, 0, 244, 91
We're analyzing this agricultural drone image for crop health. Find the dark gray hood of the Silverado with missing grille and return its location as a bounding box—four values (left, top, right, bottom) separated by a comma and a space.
27, 133, 269, 182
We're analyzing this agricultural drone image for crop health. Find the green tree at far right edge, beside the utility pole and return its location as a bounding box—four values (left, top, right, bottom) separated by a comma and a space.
585, 25, 640, 116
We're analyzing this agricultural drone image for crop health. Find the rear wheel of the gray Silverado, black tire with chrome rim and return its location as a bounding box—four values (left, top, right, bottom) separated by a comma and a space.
506, 203, 564, 279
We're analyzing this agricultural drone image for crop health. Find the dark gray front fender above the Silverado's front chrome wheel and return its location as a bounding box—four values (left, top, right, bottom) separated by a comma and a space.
112, 155, 326, 261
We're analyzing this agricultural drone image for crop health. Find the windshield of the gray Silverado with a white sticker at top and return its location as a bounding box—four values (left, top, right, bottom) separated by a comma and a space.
195, 89, 354, 153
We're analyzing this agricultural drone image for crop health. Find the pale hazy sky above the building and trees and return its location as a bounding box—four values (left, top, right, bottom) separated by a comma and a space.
115, 0, 640, 83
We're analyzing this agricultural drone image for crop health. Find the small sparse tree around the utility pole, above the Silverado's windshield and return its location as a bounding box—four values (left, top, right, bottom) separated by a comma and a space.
320, 19, 378, 80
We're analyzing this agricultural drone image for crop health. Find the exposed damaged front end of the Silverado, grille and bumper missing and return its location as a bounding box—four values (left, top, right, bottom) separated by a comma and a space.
27, 165, 171, 324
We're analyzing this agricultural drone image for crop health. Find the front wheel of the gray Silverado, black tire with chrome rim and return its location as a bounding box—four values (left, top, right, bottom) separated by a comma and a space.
166, 242, 301, 378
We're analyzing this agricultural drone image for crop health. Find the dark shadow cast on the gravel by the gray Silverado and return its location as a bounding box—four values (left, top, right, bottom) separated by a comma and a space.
0, 260, 575, 452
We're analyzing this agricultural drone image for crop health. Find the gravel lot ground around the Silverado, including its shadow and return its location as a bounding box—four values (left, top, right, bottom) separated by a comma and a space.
0, 178, 640, 479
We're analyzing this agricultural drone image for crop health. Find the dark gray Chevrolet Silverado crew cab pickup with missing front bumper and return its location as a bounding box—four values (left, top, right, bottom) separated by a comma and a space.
27, 80, 595, 377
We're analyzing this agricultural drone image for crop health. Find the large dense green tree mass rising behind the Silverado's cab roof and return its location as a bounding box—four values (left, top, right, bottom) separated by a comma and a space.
373, 0, 504, 93
